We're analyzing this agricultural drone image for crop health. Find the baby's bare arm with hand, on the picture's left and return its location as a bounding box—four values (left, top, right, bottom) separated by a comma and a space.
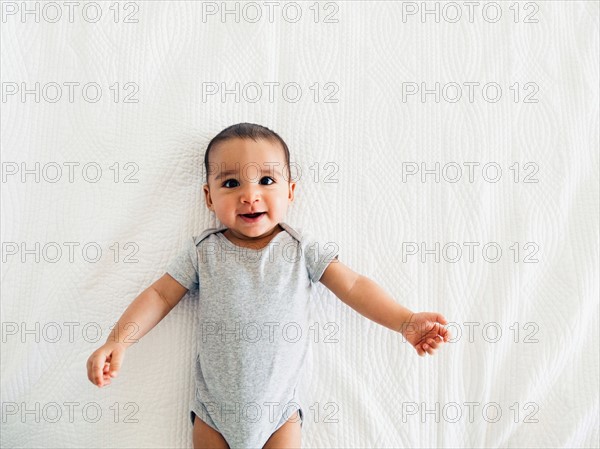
87, 274, 187, 387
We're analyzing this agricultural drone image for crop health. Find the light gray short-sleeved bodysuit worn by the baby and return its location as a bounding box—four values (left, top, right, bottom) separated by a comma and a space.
166, 223, 338, 449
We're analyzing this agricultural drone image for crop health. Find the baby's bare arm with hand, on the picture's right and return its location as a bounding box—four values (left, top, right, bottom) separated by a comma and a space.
320, 259, 450, 356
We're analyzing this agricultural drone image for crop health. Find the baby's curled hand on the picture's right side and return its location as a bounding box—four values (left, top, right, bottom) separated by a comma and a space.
401, 312, 452, 356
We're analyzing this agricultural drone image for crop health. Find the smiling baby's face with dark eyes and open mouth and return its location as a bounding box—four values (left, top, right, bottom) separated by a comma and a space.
204, 138, 296, 240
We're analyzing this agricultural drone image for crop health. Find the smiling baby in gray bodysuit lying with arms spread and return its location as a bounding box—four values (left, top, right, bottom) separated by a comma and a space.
87, 123, 451, 449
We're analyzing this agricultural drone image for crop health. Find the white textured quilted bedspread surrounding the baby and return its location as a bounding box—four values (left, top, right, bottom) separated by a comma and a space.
1, 1, 600, 448
